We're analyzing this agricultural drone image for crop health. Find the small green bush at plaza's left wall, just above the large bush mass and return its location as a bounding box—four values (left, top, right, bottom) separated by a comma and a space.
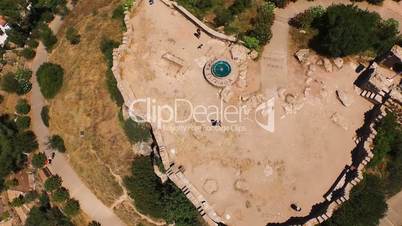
119, 112, 152, 143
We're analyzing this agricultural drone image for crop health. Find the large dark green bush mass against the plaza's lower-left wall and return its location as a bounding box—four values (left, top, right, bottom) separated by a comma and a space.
124, 156, 202, 226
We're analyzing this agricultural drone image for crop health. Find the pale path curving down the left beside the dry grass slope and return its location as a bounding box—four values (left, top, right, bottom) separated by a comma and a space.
30, 17, 125, 226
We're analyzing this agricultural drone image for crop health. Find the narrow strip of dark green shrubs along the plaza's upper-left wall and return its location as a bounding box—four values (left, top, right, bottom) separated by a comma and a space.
101, 38, 124, 106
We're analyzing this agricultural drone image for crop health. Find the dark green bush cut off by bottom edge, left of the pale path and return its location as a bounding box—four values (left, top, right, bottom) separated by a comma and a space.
25, 206, 74, 226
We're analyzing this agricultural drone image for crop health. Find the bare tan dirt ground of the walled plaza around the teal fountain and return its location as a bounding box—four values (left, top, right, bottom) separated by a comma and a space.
115, 1, 392, 226
